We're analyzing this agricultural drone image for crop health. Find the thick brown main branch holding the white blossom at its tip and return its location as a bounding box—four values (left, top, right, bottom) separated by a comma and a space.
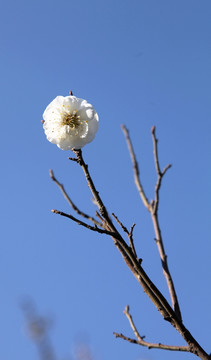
57, 150, 211, 360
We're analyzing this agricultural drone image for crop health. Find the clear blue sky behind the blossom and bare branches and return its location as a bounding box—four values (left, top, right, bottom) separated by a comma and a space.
0, 0, 211, 360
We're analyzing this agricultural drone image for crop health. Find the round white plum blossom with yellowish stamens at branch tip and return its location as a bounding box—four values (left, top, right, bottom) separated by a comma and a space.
43, 95, 99, 150
